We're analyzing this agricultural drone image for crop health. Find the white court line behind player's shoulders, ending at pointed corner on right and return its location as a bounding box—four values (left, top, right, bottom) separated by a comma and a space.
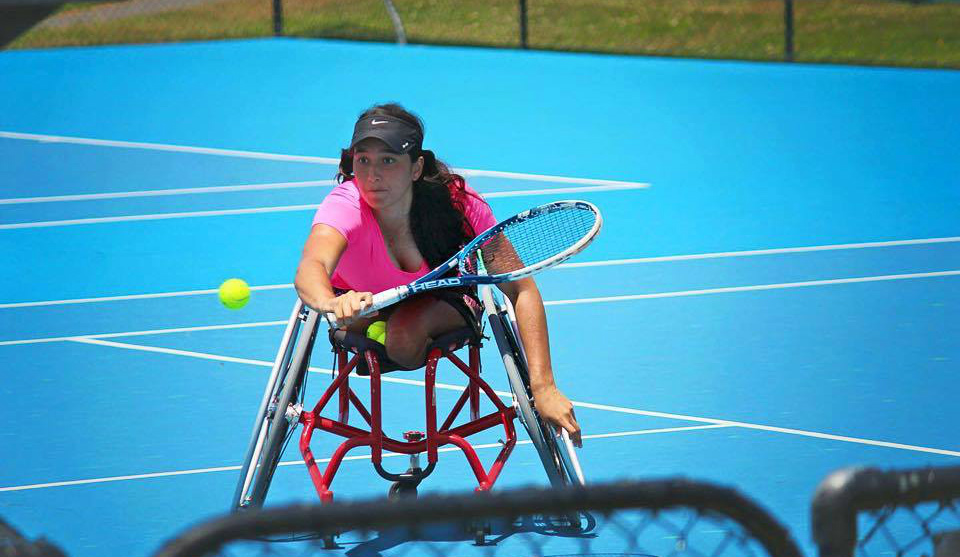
0, 180, 647, 230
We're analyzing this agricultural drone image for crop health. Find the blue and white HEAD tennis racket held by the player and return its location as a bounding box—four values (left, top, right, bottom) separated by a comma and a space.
326, 201, 603, 327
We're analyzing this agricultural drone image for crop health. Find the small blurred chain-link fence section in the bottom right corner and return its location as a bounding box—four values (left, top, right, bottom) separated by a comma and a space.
812, 466, 960, 557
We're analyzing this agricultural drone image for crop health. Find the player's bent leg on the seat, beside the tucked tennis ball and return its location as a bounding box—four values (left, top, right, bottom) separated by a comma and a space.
387, 295, 467, 368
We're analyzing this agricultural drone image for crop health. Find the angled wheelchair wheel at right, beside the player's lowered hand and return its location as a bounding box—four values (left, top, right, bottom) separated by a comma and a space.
483, 287, 585, 487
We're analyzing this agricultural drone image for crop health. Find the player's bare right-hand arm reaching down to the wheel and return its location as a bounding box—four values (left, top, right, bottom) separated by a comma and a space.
499, 278, 582, 447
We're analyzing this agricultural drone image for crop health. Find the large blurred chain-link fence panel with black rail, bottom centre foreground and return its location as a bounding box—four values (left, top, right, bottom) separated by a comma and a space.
158, 480, 801, 557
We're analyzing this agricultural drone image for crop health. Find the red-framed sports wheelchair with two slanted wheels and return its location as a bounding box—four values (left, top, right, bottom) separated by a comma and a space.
232, 287, 584, 536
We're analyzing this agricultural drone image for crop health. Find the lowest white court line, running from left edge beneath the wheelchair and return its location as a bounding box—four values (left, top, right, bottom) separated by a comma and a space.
0, 425, 726, 492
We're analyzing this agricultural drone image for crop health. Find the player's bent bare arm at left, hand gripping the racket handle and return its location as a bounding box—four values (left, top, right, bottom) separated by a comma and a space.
293, 224, 373, 324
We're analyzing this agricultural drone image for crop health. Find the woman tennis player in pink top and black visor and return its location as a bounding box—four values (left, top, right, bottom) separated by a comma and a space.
295, 104, 581, 446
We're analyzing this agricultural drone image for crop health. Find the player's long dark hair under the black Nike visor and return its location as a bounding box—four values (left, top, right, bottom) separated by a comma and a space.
337, 103, 477, 267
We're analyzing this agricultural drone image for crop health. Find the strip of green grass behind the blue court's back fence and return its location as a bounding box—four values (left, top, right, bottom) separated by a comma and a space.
12, 0, 960, 68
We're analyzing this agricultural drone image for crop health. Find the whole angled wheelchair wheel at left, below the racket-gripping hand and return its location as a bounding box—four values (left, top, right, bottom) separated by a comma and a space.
234, 304, 318, 509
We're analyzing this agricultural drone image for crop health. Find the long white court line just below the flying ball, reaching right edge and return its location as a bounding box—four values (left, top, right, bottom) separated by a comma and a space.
0, 270, 960, 346
